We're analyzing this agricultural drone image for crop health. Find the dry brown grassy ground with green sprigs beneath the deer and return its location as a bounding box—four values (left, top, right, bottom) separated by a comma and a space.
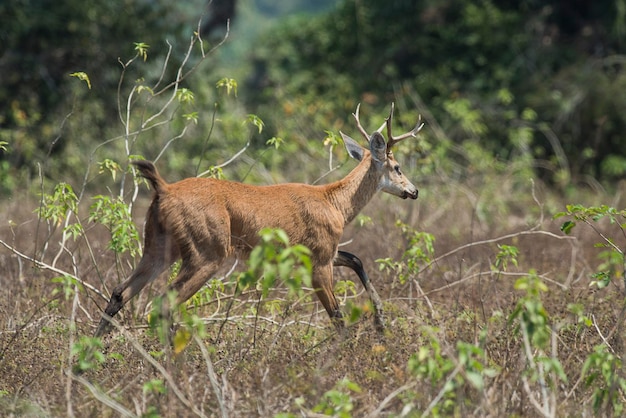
0, 177, 626, 417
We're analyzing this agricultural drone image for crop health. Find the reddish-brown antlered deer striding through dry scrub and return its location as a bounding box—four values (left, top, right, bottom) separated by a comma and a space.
95, 103, 424, 337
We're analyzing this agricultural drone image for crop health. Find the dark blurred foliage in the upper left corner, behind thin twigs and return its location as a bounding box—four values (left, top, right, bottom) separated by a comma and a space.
0, 0, 202, 192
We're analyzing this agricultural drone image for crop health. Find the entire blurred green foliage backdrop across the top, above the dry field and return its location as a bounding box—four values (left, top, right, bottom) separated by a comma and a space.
0, 0, 626, 194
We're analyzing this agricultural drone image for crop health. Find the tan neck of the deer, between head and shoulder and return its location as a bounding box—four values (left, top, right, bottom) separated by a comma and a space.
327, 153, 382, 224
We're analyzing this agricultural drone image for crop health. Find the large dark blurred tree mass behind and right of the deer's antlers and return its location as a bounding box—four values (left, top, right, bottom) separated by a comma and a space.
245, 0, 626, 187
